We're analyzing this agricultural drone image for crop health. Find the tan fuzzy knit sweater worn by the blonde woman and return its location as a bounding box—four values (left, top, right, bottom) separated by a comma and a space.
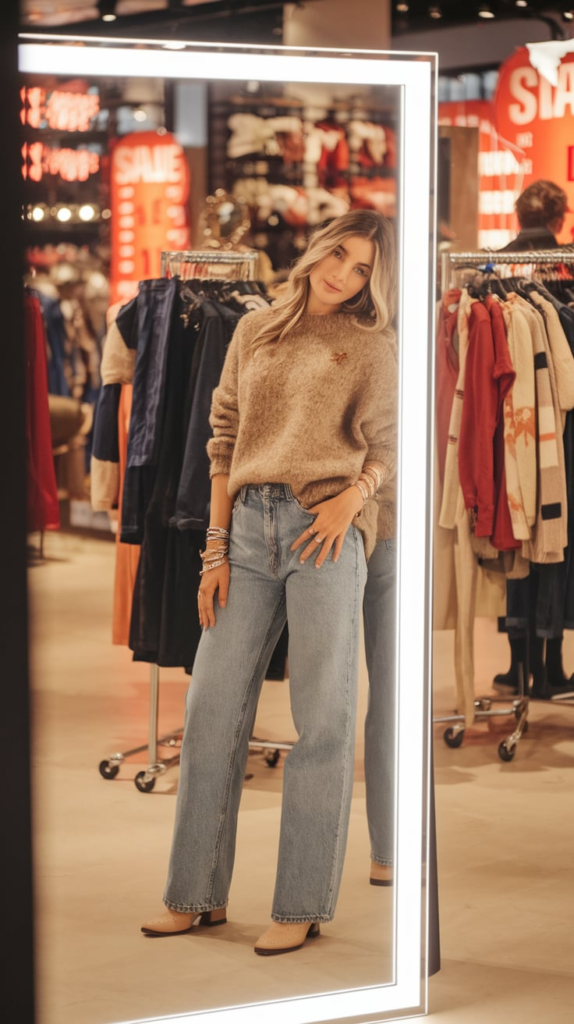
208, 309, 397, 558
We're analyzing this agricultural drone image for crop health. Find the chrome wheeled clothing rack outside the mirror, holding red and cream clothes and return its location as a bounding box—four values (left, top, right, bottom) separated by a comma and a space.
433, 249, 574, 761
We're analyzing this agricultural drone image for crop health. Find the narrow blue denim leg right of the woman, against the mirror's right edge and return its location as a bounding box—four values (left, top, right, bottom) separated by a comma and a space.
363, 540, 397, 864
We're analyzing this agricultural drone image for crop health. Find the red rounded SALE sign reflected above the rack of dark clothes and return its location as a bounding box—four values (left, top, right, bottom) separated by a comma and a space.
111, 131, 190, 302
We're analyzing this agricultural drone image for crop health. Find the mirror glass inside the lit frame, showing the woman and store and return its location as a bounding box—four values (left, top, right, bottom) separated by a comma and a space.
23, 68, 400, 1024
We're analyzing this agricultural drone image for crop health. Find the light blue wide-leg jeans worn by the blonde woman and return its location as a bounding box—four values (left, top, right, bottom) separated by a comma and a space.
164, 484, 366, 922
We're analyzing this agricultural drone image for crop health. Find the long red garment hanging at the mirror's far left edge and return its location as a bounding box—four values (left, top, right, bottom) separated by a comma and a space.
24, 293, 59, 532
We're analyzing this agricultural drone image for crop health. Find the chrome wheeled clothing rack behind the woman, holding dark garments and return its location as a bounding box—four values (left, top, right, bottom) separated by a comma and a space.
99, 250, 293, 793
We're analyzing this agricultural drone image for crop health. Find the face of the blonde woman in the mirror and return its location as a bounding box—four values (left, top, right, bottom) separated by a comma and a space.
307, 234, 374, 313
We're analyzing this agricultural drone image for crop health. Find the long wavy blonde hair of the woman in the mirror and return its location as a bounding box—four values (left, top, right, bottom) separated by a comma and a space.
253, 210, 397, 348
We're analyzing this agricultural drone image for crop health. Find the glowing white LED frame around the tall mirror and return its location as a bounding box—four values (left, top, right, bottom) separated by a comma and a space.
19, 34, 437, 1024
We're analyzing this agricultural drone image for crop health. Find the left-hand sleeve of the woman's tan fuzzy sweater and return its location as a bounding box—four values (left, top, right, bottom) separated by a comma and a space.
208, 314, 242, 477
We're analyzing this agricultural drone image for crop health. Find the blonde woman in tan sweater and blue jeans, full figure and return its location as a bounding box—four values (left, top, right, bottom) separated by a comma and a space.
142, 211, 397, 954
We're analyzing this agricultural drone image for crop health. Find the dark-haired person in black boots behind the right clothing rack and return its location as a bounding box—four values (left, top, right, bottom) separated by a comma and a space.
493, 180, 571, 697
